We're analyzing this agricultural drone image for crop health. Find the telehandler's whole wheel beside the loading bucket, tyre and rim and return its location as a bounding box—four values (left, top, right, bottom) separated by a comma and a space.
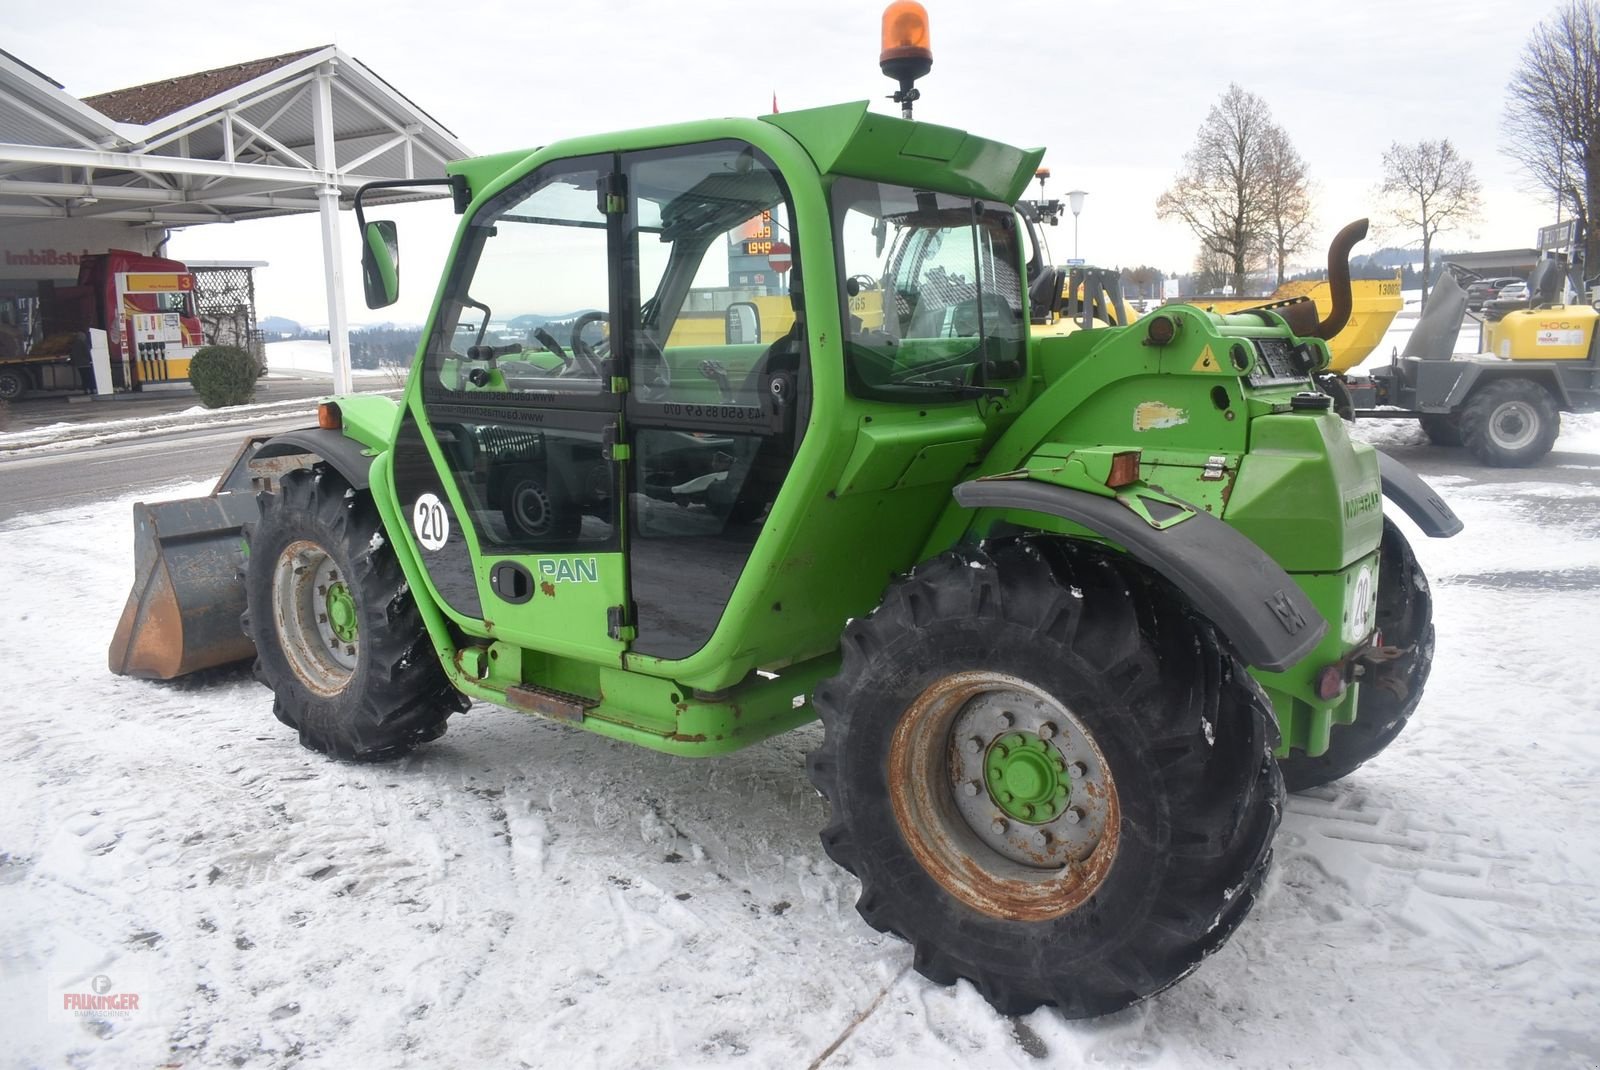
243, 465, 466, 761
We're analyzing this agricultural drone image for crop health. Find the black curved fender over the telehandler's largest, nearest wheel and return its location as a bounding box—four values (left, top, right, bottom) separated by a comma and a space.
954, 480, 1328, 672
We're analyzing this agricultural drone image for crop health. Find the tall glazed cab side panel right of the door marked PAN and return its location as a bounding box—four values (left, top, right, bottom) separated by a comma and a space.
619, 139, 810, 661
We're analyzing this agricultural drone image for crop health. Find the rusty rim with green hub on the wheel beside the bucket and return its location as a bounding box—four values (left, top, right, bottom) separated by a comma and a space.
272, 539, 360, 697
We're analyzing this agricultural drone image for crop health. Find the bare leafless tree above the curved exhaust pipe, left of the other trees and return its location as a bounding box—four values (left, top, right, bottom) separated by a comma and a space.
1155, 83, 1275, 293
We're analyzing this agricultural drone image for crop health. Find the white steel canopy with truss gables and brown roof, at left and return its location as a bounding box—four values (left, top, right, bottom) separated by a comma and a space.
0, 45, 470, 392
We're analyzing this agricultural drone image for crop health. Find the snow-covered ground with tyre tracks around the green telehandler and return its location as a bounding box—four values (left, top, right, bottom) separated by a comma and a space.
0, 374, 1600, 1068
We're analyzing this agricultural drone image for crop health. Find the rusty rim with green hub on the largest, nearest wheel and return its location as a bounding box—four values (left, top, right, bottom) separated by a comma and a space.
888, 672, 1120, 921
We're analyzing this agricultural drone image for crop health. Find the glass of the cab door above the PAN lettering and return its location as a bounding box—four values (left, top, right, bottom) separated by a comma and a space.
424, 157, 619, 553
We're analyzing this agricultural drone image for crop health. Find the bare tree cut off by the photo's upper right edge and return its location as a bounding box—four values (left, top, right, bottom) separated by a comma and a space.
1502, 0, 1600, 273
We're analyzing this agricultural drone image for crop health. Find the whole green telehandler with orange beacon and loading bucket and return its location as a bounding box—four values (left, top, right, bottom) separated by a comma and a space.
110, 3, 1461, 1017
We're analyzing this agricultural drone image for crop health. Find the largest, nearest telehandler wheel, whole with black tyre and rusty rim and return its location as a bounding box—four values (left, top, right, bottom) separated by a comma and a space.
810, 539, 1283, 1017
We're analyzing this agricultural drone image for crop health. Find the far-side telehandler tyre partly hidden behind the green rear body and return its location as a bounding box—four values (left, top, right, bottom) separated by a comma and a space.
1278, 517, 1434, 792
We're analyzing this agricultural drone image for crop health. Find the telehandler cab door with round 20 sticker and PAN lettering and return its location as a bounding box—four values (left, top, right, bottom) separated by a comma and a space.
394, 154, 627, 661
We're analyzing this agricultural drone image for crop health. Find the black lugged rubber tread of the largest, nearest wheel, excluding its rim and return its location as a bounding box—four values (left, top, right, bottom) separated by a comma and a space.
808, 539, 1283, 1017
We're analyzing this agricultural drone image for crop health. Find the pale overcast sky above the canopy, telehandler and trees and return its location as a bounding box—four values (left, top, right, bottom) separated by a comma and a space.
5, 0, 1557, 323
